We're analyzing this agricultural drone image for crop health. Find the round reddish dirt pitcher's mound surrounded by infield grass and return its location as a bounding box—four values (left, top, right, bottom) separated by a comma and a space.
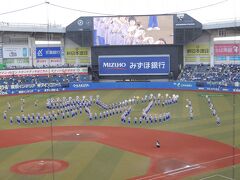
11, 159, 68, 175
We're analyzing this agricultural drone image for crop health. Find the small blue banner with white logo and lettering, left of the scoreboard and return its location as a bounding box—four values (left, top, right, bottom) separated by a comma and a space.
36, 47, 61, 59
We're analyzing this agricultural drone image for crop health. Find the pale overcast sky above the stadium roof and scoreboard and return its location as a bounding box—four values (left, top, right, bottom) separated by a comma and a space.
0, 0, 240, 26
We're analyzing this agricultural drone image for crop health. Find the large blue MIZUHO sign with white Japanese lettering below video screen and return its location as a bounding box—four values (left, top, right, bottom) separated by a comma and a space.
98, 55, 170, 76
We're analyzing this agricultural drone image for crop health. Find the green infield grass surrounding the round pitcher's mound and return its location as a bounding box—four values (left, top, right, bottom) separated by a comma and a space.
0, 141, 149, 180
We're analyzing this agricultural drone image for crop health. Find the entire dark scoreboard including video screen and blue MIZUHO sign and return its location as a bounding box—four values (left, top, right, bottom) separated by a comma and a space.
66, 14, 202, 80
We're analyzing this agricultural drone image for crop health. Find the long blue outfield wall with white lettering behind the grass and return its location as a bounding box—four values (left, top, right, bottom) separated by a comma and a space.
0, 81, 240, 95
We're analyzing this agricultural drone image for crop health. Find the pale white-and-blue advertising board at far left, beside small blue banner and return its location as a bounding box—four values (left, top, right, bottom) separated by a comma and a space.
3, 47, 29, 59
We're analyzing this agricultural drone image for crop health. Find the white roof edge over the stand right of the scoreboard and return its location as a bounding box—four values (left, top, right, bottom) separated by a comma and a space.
203, 19, 240, 30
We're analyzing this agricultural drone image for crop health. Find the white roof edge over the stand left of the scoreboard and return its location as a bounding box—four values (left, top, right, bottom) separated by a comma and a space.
0, 22, 66, 33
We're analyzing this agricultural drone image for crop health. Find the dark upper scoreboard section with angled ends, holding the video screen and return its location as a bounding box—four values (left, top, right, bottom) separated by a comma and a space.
66, 14, 202, 47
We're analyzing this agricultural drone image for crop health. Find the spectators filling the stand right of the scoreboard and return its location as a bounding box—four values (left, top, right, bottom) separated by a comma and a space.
178, 64, 240, 86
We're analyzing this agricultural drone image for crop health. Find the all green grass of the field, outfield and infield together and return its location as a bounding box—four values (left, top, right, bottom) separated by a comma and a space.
0, 90, 240, 180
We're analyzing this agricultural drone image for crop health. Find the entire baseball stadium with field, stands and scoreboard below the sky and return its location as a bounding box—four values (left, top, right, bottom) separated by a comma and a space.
0, 1, 240, 180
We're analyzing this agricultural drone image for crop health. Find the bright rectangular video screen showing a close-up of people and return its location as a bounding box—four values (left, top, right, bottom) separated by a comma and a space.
93, 15, 174, 46
